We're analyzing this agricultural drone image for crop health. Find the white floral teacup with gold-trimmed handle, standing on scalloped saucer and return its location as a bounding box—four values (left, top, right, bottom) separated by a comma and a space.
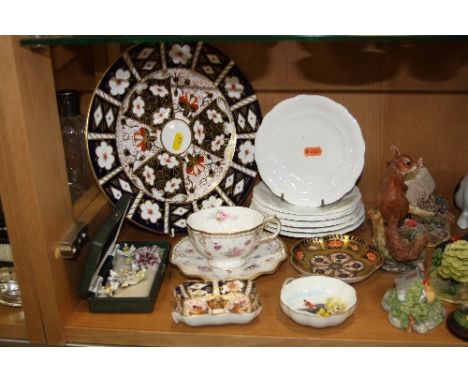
187, 207, 281, 269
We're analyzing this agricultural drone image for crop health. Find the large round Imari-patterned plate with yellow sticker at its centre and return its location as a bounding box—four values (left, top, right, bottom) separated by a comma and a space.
86, 42, 261, 234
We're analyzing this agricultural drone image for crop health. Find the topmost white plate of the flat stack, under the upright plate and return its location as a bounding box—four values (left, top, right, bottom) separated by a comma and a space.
252, 182, 362, 220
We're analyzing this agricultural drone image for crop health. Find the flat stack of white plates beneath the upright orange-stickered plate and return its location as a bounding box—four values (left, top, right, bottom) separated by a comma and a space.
250, 182, 365, 238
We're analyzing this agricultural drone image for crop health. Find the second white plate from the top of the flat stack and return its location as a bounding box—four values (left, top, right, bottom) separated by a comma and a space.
250, 201, 364, 228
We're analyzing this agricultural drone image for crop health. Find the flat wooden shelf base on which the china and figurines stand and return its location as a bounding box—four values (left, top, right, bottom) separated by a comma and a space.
65, 223, 466, 346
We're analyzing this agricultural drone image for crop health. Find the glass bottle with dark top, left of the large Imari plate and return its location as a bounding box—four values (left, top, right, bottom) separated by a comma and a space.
57, 90, 91, 202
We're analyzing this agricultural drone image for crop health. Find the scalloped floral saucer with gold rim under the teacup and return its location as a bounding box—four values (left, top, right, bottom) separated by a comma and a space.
170, 236, 287, 280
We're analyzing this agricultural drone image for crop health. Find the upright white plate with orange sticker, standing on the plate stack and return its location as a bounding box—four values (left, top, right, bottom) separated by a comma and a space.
255, 95, 365, 207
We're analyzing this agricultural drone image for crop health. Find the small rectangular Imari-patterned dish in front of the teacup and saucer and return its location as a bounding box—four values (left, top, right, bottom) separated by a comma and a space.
172, 280, 262, 326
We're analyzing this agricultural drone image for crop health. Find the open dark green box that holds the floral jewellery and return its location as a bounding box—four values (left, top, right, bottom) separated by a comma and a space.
79, 194, 170, 313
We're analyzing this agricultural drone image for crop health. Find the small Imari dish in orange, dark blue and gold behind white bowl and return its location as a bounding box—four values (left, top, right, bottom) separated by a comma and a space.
290, 235, 384, 284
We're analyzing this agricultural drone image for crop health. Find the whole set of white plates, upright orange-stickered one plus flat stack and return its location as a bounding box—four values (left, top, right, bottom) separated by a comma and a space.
251, 95, 365, 238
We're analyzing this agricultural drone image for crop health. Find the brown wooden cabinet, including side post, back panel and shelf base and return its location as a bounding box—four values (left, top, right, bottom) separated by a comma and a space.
0, 36, 468, 346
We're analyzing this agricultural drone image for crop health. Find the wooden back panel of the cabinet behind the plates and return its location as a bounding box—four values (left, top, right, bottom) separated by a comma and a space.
52, 40, 468, 207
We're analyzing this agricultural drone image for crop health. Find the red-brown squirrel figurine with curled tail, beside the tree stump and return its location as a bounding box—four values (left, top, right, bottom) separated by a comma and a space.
377, 146, 429, 261
